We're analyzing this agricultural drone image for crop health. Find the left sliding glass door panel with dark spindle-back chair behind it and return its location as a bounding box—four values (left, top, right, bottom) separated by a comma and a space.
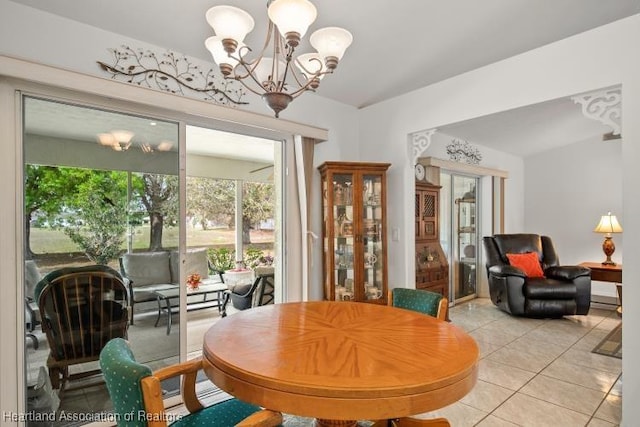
20, 96, 180, 413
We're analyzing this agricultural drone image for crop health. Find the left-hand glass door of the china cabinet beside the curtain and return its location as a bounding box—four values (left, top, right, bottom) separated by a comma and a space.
330, 174, 355, 301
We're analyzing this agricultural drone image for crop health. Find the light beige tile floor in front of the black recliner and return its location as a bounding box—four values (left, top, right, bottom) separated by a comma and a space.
419, 299, 622, 427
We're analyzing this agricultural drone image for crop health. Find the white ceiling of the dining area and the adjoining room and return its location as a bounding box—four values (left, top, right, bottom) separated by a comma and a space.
12, 0, 640, 155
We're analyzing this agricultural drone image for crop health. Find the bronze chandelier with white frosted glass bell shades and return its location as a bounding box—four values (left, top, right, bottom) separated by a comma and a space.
205, 0, 353, 117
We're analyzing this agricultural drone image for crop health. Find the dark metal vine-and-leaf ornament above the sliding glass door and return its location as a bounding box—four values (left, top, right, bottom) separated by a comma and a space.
97, 46, 248, 106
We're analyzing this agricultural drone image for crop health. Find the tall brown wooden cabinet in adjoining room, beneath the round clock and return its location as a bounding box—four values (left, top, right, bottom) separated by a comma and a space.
415, 181, 449, 298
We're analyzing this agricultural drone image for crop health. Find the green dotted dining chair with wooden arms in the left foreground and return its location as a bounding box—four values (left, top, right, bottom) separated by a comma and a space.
100, 338, 282, 427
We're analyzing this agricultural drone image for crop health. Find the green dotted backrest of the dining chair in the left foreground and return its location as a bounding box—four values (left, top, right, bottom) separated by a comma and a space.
100, 338, 152, 427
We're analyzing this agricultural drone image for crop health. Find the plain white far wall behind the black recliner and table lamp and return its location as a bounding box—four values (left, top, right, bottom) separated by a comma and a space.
524, 138, 626, 297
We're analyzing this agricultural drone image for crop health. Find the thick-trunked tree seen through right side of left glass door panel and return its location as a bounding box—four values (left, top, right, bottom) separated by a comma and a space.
134, 173, 178, 251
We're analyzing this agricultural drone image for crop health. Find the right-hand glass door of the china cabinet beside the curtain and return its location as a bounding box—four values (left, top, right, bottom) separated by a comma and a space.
358, 175, 384, 300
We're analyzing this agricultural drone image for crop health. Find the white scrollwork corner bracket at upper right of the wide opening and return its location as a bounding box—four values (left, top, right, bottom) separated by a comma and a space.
571, 88, 622, 135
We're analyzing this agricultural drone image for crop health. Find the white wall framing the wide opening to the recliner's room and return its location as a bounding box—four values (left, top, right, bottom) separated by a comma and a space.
359, 15, 640, 425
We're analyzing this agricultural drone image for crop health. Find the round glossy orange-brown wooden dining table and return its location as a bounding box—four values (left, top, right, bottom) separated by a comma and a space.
203, 301, 479, 426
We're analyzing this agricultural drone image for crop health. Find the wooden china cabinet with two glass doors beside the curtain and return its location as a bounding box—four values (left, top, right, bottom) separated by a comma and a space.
318, 162, 391, 304
